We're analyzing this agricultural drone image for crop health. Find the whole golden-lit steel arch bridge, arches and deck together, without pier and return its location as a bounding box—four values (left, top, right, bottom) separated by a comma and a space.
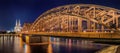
21, 4, 120, 38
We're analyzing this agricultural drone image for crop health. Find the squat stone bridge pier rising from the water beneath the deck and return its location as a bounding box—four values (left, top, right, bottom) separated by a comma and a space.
22, 35, 50, 44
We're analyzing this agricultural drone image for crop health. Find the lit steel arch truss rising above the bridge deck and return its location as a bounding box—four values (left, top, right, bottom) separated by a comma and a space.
30, 4, 120, 32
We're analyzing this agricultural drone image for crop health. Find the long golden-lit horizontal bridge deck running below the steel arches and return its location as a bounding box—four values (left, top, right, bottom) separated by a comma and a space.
23, 32, 120, 39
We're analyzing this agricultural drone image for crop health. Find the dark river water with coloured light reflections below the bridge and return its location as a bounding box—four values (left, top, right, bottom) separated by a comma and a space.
0, 36, 118, 53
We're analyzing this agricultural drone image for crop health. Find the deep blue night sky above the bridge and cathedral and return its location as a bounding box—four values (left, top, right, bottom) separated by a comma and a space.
0, 0, 120, 30
